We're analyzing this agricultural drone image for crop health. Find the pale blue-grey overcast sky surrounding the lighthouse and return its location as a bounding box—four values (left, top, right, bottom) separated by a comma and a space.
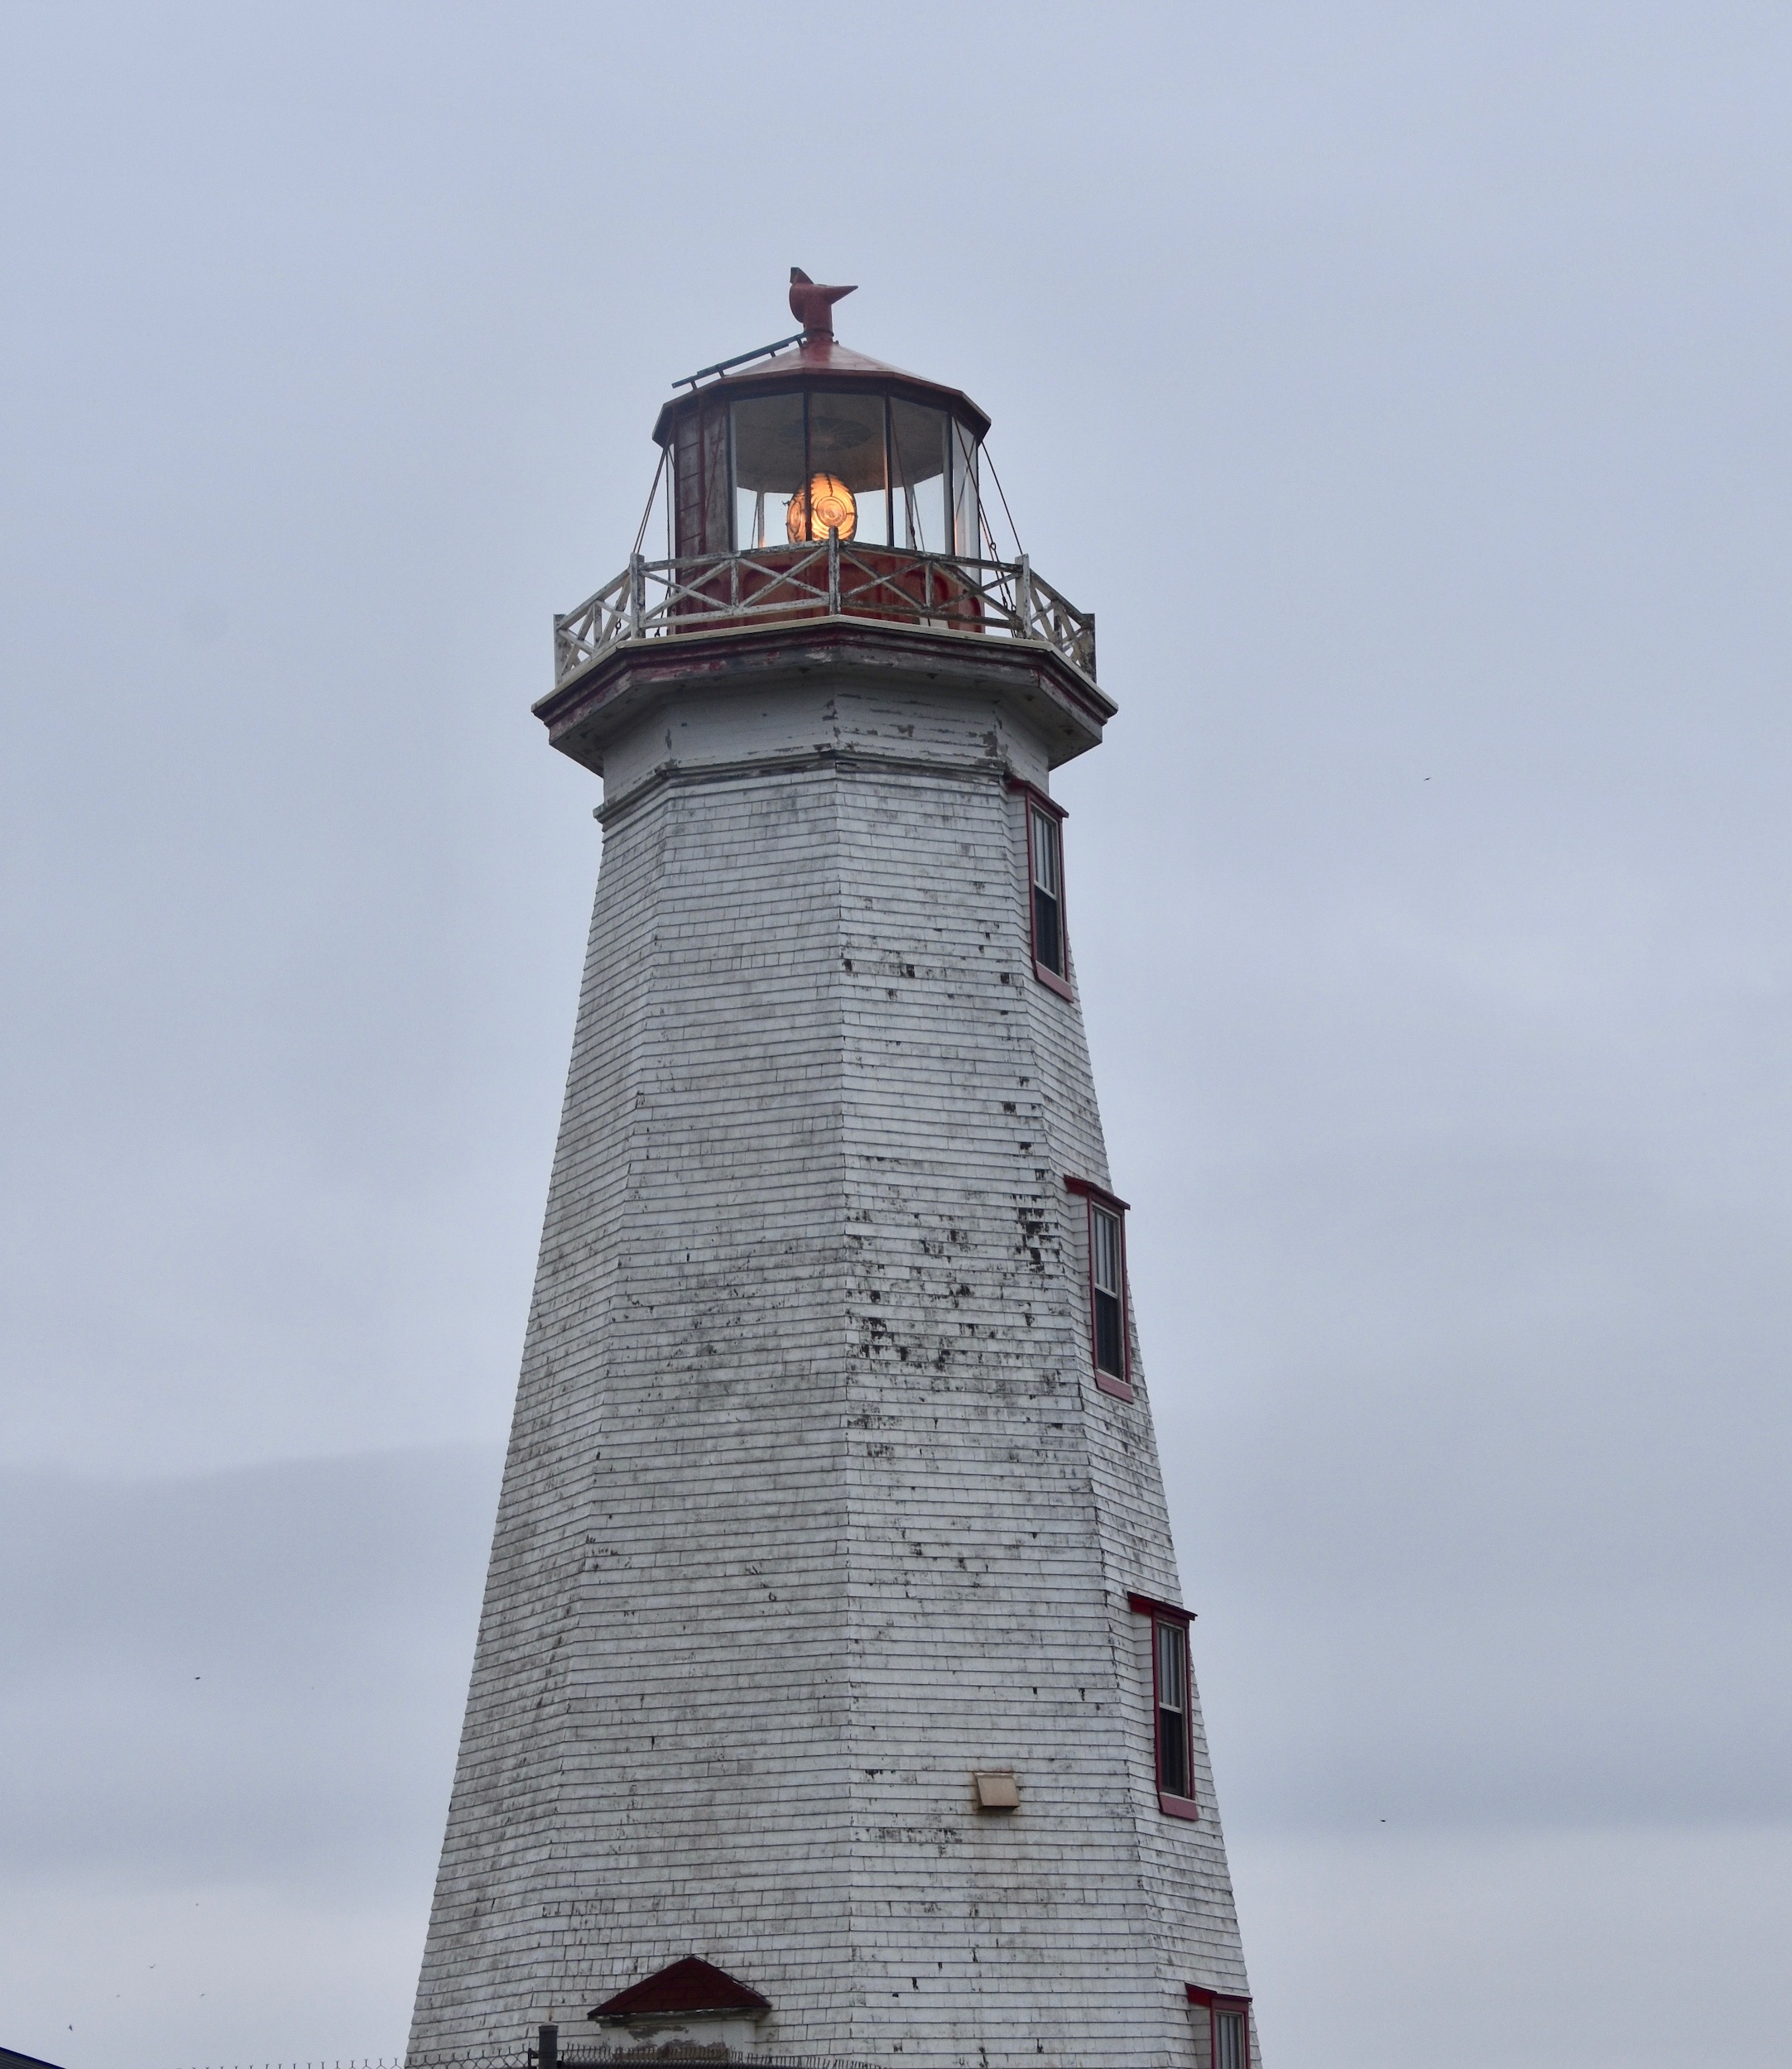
0, 12, 1792, 2069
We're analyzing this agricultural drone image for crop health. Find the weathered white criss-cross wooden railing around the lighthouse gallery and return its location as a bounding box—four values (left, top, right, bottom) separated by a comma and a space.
555, 536, 1095, 689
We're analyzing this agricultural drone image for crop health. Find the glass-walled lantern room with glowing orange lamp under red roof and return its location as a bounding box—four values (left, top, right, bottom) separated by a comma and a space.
654, 290, 989, 561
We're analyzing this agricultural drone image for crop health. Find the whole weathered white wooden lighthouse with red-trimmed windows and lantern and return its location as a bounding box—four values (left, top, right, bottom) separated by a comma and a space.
410, 273, 1256, 2069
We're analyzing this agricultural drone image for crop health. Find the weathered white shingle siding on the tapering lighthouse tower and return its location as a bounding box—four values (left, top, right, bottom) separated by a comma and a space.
412, 674, 1248, 2069
